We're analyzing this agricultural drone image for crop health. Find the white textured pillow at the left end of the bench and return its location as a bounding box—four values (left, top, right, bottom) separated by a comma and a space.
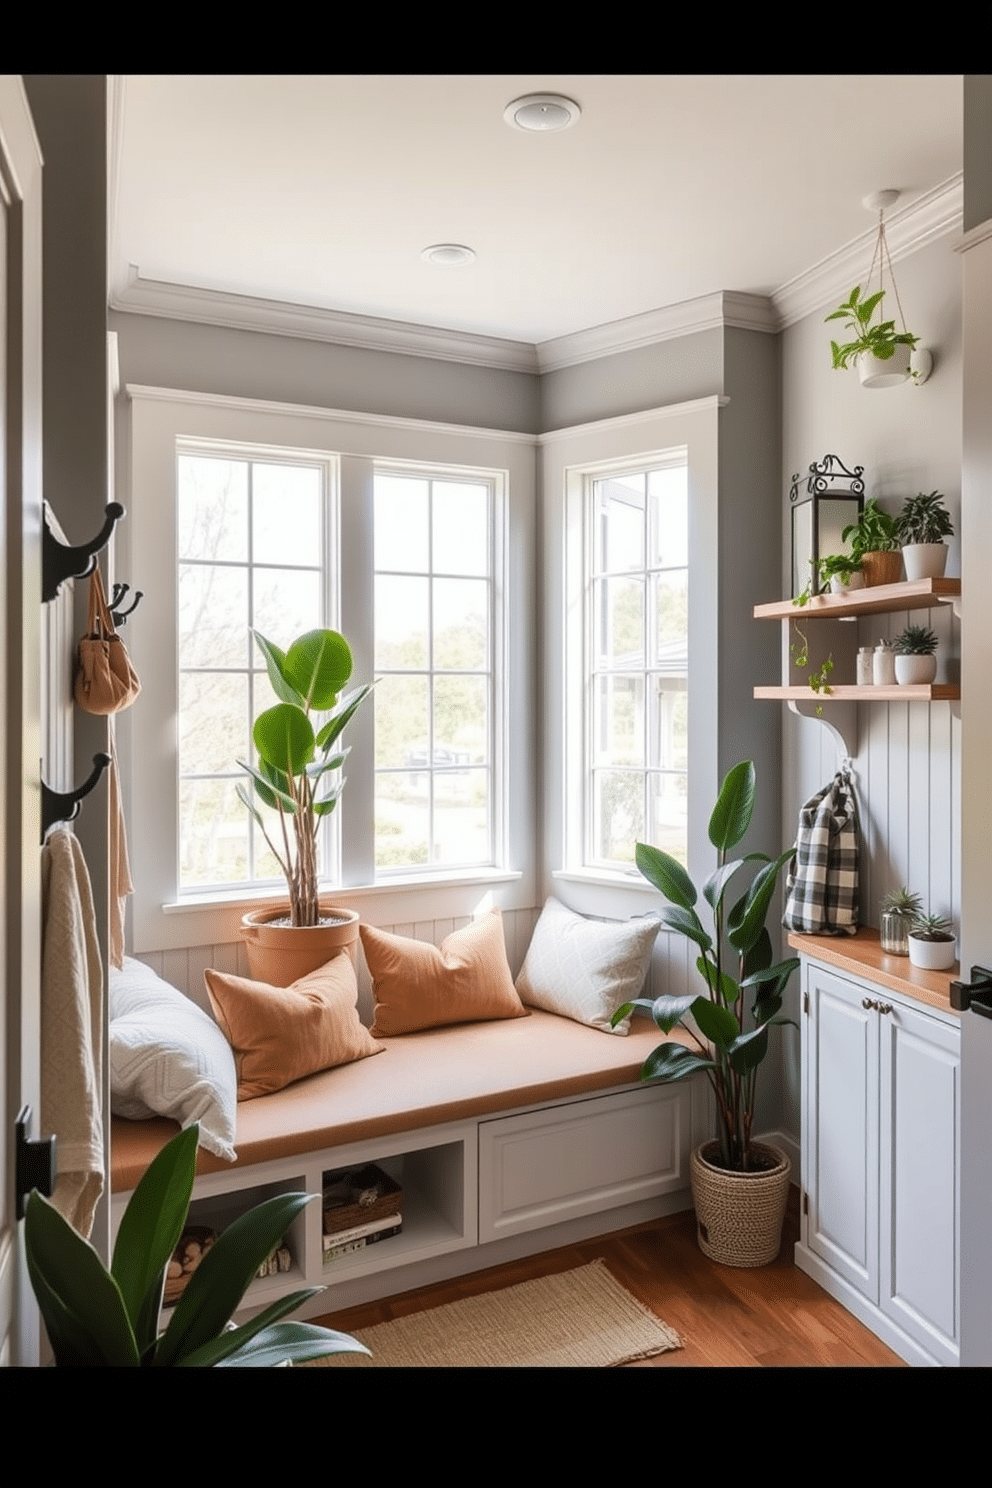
110, 955, 238, 1162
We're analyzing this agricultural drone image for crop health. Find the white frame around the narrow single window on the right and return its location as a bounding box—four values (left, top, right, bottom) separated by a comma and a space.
541, 396, 726, 918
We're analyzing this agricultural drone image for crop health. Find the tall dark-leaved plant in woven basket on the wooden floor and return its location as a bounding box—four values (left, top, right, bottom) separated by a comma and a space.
613, 760, 799, 1266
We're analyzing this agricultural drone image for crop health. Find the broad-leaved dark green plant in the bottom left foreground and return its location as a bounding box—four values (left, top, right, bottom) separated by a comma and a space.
24, 1125, 369, 1369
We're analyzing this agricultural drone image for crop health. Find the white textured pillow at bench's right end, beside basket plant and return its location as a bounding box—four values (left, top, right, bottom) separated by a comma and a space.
516, 899, 660, 1034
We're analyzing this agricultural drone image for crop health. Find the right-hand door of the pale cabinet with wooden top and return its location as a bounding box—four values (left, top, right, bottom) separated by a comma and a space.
879, 1003, 961, 1363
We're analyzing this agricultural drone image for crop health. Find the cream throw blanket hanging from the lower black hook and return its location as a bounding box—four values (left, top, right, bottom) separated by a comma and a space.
42, 827, 104, 1238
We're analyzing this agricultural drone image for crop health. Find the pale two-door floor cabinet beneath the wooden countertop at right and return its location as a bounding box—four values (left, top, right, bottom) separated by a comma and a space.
796, 957, 961, 1364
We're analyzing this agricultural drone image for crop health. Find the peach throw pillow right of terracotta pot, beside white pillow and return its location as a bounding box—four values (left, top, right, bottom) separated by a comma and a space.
360, 909, 528, 1039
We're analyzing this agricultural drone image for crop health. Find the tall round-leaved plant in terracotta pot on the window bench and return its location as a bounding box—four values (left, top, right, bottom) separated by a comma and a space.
238, 631, 372, 987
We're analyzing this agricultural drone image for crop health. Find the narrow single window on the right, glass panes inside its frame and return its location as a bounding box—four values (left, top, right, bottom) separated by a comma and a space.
584, 449, 689, 868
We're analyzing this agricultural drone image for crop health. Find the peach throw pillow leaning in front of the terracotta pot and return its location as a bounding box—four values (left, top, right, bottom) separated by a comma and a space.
204, 952, 382, 1101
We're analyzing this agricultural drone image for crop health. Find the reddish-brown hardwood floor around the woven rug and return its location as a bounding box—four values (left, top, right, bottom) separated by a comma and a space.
315, 1186, 903, 1369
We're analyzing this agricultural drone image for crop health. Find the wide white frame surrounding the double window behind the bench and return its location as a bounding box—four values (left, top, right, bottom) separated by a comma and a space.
123, 387, 538, 952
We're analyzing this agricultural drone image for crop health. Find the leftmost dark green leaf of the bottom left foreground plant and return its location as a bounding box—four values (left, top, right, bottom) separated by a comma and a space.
24, 1189, 138, 1367
